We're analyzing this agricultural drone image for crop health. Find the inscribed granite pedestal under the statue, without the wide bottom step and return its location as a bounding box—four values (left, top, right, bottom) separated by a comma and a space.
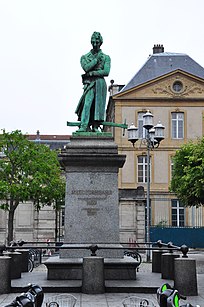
59, 134, 125, 258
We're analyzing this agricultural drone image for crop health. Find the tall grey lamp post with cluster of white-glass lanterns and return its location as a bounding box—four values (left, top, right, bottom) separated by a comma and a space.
128, 111, 165, 262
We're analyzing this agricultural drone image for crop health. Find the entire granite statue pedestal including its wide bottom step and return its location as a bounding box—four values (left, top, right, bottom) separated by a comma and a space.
45, 133, 138, 279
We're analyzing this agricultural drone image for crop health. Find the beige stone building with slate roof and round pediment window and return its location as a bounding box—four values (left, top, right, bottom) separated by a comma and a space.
107, 45, 204, 242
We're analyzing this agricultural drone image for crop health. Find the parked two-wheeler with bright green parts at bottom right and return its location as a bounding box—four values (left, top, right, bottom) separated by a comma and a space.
157, 283, 200, 307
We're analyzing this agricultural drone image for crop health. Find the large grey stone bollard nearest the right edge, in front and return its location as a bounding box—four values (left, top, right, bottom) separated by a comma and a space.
174, 258, 198, 296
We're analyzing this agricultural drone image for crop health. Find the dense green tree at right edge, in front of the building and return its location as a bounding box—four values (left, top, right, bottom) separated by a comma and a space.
170, 137, 204, 207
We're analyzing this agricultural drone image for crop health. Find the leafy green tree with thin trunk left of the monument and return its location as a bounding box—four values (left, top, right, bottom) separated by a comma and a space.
0, 130, 65, 243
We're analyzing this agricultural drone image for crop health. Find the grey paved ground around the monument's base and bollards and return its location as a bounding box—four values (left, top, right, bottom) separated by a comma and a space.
0, 255, 204, 307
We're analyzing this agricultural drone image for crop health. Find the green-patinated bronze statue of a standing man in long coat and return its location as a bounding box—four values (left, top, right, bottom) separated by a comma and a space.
75, 32, 111, 132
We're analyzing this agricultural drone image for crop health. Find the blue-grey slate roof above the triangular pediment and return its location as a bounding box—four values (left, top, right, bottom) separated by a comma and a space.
120, 52, 204, 93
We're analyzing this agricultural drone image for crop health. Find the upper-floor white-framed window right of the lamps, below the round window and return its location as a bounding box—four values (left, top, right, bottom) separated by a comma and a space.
171, 112, 184, 139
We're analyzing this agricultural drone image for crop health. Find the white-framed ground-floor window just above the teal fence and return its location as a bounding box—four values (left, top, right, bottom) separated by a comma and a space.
171, 199, 184, 227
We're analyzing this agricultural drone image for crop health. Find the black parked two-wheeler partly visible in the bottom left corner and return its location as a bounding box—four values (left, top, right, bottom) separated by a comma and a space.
4, 284, 44, 307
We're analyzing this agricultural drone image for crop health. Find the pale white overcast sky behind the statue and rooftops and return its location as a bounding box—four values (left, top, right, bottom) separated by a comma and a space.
0, 0, 204, 134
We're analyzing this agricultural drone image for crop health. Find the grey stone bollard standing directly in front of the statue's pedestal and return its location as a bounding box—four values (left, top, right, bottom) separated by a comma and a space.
82, 257, 105, 294
